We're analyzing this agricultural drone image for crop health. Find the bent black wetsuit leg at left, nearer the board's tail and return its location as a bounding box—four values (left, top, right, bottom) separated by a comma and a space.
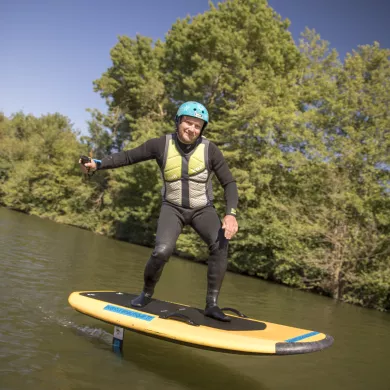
131, 203, 184, 307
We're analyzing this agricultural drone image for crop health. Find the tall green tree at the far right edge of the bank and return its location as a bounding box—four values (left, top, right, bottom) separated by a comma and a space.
298, 39, 390, 309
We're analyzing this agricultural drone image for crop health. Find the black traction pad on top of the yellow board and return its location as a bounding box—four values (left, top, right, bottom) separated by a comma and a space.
80, 291, 267, 331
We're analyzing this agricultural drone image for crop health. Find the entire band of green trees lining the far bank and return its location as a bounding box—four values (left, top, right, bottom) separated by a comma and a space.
0, 0, 390, 311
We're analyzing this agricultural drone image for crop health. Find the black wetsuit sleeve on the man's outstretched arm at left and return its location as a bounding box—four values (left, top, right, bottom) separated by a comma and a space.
98, 136, 165, 170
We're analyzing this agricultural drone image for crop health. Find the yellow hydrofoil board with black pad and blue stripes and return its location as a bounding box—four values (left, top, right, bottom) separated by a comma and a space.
69, 291, 333, 355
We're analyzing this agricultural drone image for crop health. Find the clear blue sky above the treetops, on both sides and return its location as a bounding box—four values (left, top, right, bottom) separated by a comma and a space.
0, 0, 390, 134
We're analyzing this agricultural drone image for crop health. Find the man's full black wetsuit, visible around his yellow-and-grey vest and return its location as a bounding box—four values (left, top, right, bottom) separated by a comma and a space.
98, 134, 238, 320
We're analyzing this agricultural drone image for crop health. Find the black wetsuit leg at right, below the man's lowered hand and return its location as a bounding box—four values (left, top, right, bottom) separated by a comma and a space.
191, 206, 230, 321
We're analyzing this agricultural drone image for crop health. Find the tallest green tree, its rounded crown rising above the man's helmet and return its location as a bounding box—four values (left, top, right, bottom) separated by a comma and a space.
162, 1, 299, 258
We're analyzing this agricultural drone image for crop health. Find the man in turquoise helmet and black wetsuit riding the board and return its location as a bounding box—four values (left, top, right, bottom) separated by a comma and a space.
83, 101, 238, 321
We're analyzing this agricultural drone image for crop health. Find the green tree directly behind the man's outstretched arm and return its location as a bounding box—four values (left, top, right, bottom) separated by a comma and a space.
87, 36, 173, 245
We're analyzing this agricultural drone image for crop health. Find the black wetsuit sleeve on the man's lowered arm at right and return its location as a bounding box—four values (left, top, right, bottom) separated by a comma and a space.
209, 142, 238, 216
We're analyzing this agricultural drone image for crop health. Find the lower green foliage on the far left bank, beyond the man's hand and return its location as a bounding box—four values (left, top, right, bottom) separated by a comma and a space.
0, 113, 97, 226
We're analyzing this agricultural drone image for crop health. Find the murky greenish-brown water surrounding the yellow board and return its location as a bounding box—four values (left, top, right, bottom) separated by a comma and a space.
0, 208, 390, 390
